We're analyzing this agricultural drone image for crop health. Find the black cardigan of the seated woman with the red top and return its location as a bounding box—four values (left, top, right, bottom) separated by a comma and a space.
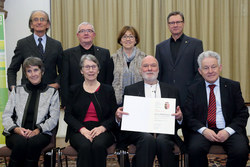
64, 83, 118, 142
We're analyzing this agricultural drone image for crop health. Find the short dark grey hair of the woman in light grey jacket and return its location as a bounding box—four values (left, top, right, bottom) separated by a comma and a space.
23, 57, 45, 74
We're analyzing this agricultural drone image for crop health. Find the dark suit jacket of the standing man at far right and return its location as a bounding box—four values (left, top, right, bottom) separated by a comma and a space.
156, 34, 203, 105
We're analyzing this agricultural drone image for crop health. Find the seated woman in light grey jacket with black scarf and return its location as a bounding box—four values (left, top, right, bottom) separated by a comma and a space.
2, 57, 60, 167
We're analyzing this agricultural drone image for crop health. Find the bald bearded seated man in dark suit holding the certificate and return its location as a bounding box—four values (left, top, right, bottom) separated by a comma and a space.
116, 56, 182, 167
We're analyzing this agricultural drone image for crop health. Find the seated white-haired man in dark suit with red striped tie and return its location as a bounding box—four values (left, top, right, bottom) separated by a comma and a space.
183, 51, 249, 167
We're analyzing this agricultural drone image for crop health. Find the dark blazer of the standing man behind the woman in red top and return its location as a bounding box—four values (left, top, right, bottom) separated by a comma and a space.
61, 45, 114, 106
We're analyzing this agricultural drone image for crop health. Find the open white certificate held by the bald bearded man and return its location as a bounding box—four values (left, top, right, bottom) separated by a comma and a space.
121, 95, 176, 135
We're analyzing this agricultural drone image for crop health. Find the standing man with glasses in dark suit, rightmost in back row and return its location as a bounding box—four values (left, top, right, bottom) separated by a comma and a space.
155, 11, 203, 105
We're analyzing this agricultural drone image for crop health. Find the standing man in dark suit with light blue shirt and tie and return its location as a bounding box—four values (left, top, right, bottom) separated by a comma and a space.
7, 10, 63, 90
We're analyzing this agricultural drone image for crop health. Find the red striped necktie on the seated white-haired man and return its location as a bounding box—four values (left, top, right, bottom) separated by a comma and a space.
207, 85, 216, 128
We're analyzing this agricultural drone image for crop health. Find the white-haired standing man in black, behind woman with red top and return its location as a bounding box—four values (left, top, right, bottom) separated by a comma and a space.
61, 22, 114, 106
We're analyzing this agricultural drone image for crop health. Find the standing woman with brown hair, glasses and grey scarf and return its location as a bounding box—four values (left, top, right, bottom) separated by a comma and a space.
111, 26, 146, 106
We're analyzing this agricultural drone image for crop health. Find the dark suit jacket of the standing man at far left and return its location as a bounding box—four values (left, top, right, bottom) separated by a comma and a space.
7, 34, 63, 89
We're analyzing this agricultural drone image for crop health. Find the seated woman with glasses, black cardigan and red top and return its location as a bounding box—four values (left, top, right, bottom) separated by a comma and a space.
64, 54, 117, 167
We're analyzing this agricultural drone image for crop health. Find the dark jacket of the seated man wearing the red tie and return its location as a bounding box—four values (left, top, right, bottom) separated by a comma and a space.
183, 77, 249, 140
